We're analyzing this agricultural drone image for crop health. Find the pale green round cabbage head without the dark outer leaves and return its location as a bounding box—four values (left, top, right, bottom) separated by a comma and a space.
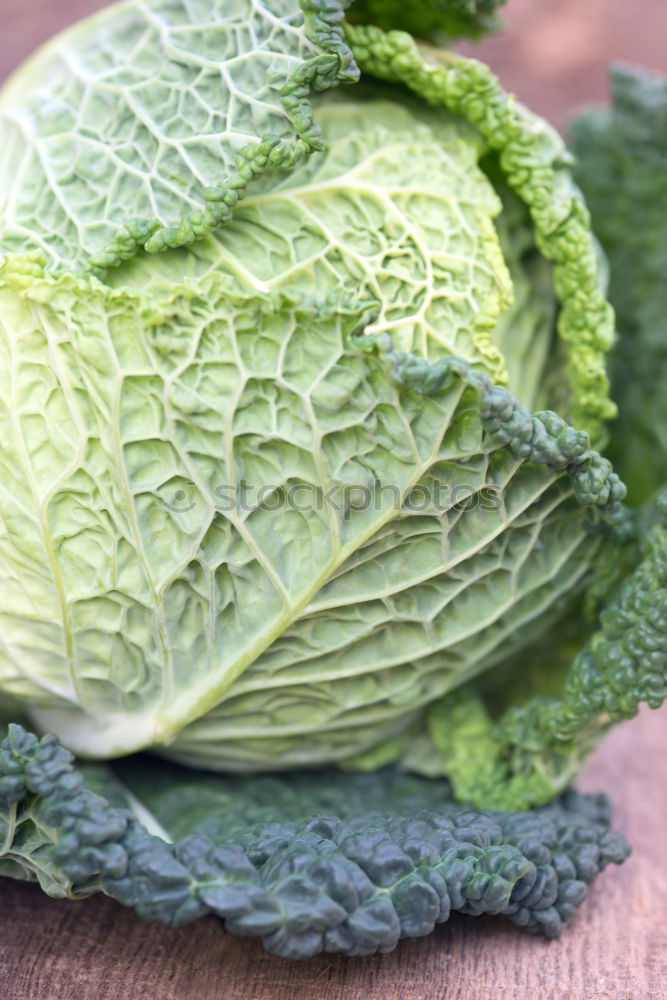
0, 0, 625, 805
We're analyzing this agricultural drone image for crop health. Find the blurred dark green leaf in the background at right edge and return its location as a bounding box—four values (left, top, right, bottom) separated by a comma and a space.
572, 65, 667, 503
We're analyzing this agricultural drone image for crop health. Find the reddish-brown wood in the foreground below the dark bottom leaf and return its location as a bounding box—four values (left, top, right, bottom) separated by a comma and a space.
0, 709, 667, 1000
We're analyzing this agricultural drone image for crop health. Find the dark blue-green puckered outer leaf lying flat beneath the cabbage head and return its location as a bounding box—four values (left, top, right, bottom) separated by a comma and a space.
0, 726, 628, 958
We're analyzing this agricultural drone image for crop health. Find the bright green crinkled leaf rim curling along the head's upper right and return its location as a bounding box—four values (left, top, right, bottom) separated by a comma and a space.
345, 25, 616, 438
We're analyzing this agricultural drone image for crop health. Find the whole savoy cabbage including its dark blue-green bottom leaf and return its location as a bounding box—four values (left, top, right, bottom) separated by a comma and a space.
0, 0, 667, 955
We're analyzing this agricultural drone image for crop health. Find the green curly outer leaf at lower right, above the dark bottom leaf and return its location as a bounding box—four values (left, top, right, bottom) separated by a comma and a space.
429, 490, 667, 809
